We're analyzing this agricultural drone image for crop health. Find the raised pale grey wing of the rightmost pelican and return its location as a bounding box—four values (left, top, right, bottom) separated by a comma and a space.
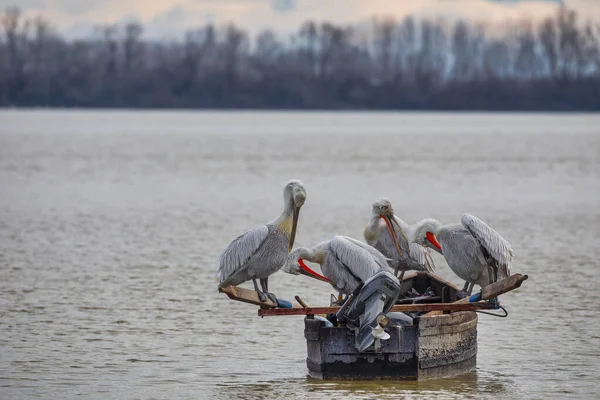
460, 214, 514, 277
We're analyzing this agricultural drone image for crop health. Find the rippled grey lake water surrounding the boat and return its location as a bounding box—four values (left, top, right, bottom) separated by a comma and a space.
0, 110, 600, 399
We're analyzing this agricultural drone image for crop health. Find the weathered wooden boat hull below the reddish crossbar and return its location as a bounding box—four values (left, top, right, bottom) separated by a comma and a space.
304, 311, 477, 379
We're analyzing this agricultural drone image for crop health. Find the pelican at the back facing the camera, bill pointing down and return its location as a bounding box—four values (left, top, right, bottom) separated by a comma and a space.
364, 197, 435, 281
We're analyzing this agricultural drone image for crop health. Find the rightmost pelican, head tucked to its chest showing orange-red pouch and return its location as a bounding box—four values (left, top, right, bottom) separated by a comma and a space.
411, 214, 514, 295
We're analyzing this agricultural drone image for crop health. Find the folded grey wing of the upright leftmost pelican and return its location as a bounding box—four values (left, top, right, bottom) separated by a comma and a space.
217, 225, 269, 283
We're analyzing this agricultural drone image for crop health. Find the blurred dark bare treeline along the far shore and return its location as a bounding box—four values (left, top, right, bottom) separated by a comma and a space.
0, 7, 600, 110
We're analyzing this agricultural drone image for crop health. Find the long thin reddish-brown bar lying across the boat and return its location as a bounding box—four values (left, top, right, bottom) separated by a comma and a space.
258, 302, 494, 317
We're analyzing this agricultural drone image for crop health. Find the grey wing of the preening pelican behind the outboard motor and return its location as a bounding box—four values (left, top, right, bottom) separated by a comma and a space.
328, 236, 387, 287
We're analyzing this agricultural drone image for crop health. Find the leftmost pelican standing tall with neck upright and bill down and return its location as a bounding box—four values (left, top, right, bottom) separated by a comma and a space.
217, 180, 306, 302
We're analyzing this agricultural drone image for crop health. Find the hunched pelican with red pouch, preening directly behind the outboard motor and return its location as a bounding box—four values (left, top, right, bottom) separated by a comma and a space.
283, 236, 389, 298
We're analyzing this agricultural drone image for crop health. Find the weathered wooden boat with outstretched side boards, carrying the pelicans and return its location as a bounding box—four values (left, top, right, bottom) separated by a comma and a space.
220, 272, 528, 380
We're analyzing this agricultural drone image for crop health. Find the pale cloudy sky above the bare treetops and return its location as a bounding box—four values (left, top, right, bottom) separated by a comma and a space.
0, 0, 600, 37
